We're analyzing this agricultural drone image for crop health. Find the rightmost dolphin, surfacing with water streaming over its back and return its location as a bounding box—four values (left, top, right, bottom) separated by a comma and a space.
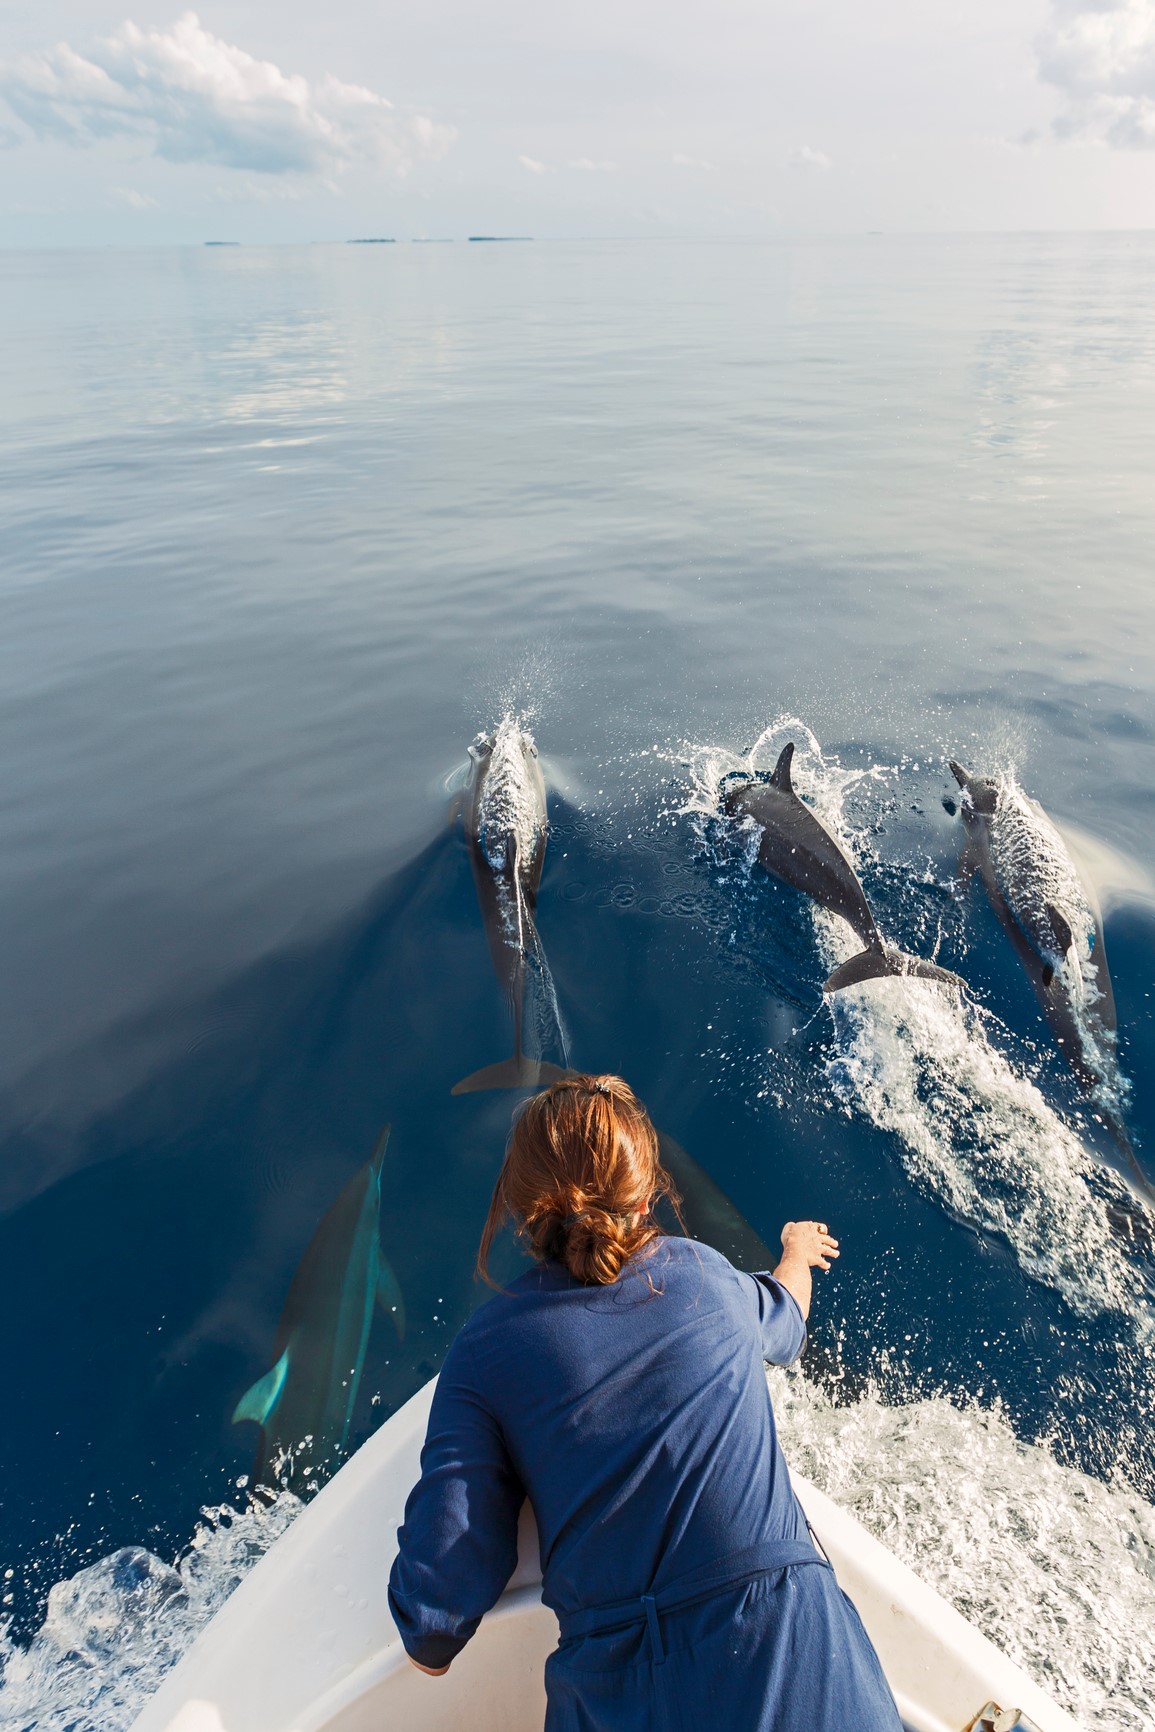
951, 759, 1155, 1202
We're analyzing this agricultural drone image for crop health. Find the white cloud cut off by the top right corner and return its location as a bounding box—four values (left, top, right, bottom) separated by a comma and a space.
1037, 0, 1155, 151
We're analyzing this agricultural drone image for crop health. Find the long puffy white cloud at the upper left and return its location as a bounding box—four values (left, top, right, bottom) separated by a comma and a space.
0, 12, 455, 175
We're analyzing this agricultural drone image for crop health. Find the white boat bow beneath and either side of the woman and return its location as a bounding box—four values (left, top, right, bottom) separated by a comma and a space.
133, 1382, 1079, 1732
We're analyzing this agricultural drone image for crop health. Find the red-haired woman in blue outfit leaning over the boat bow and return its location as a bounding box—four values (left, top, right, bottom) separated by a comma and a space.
390, 1077, 900, 1732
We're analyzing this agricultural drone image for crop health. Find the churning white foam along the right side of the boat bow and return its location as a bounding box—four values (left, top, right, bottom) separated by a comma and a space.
769, 1372, 1155, 1732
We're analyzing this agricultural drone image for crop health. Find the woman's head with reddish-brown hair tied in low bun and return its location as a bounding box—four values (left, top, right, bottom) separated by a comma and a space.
478, 1076, 679, 1285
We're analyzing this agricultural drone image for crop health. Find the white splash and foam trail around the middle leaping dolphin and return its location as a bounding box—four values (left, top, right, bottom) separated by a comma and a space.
679, 717, 1155, 1339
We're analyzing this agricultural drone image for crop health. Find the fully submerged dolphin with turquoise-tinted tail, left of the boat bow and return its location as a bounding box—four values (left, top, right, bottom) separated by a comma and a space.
232, 1126, 405, 1484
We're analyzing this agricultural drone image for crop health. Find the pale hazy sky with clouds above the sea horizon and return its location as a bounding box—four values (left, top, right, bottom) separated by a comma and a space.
0, 0, 1155, 246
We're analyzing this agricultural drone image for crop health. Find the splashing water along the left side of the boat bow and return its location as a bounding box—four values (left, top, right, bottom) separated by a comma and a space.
0, 1491, 301, 1732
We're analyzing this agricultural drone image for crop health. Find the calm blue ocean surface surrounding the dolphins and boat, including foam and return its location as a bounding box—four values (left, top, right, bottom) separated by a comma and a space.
0, 236, 1155, 1732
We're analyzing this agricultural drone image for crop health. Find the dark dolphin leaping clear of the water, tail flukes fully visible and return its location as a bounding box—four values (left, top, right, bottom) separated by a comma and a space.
722, 740, 963, 992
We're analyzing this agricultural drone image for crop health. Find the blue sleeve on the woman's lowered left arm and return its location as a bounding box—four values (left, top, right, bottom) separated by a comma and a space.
390, 1337, 525, 1666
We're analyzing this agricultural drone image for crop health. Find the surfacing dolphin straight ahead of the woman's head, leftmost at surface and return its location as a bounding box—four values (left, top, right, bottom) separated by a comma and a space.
452, 715, 570, 1095
